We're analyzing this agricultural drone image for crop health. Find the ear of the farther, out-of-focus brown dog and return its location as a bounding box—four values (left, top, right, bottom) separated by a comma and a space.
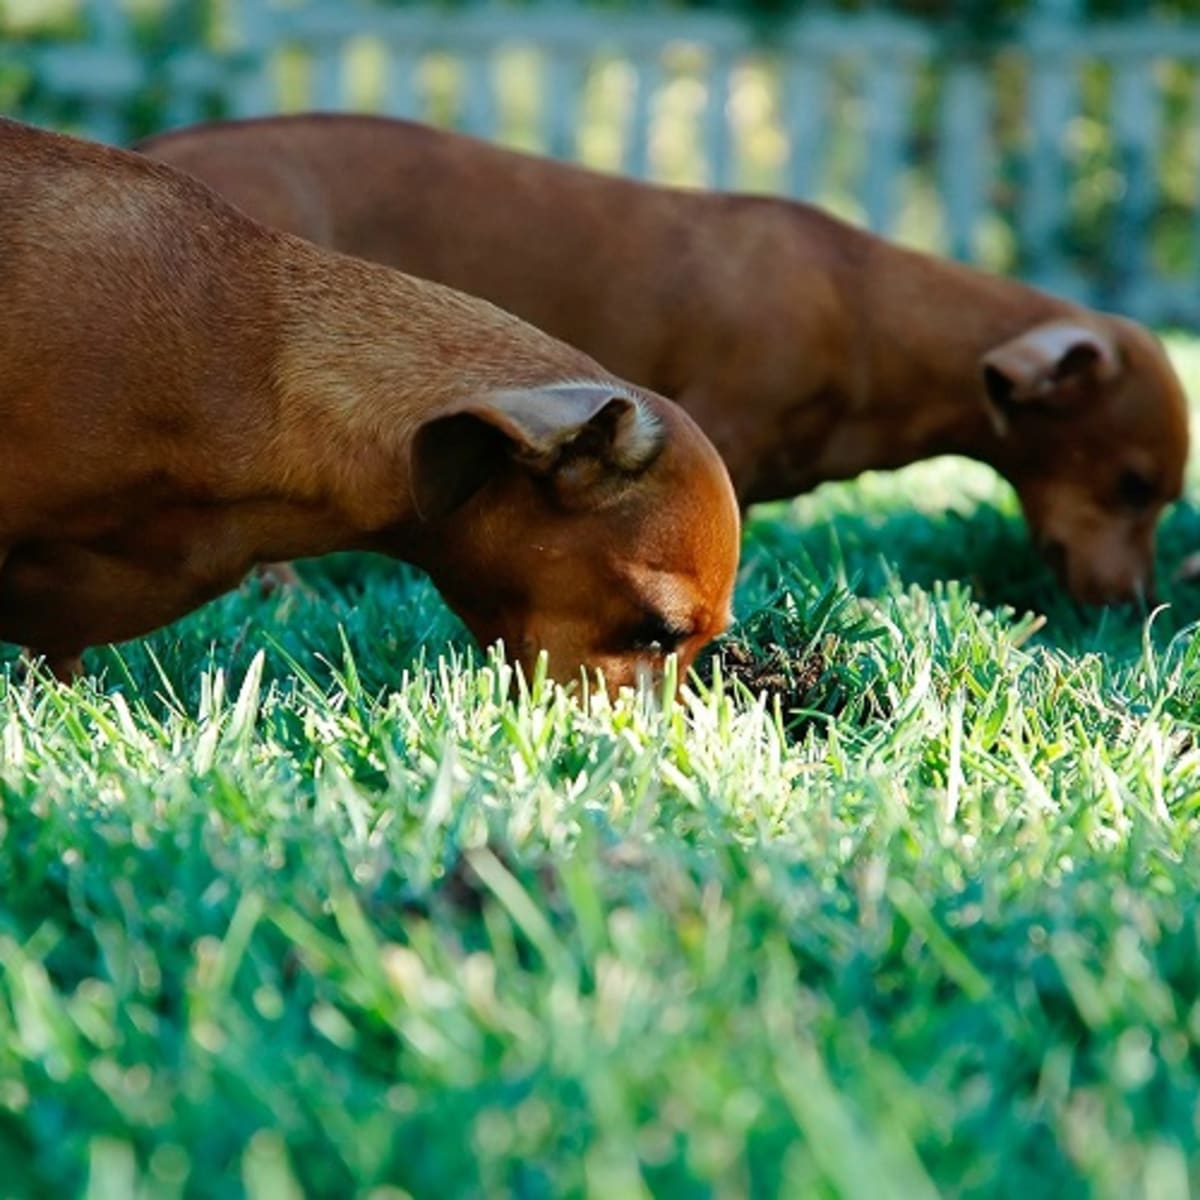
980, 320, 1121, 432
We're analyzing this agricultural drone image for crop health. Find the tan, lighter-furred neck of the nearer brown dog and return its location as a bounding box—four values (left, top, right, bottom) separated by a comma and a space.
260, 239, 586, 553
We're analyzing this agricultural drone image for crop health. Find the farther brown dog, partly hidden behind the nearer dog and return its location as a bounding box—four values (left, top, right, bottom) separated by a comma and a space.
142, 115, 1188, 602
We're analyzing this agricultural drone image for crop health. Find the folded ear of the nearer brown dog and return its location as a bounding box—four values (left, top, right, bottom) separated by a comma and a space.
409, 383, 665, 521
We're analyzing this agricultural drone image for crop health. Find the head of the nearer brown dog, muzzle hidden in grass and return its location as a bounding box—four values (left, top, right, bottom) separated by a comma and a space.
410, 382, 739, 688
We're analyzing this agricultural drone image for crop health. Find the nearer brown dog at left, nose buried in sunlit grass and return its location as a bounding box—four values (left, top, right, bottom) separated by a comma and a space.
0, 121, 738, 685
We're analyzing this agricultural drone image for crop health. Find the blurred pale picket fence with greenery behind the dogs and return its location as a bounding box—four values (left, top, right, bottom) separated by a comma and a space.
0, 0, 1200, 325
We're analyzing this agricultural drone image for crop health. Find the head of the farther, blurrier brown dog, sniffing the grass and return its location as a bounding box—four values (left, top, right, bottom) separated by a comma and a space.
980, 313, 1188, 604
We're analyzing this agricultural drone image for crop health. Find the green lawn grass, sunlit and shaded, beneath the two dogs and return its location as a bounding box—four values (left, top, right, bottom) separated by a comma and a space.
7, 342, 1200, 1200
